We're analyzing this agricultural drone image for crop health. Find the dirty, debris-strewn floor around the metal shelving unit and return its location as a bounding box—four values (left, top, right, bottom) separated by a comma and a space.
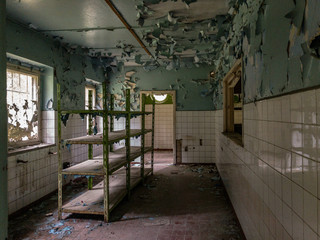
9, 152, 245, 240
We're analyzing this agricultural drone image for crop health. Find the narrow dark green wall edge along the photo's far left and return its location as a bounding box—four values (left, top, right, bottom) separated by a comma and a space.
0, 1, 8, 240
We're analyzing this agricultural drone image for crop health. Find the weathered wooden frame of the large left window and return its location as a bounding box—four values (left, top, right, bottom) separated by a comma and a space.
6, 63, 42, 149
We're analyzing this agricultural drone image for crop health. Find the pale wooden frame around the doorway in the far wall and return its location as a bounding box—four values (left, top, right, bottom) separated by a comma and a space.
140, 90, 177, 164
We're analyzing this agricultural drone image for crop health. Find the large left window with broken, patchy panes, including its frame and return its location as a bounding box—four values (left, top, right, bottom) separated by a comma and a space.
7, 66, 40, 147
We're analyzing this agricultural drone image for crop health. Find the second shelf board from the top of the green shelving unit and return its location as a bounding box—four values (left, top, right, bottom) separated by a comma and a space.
64, 129, 152, 144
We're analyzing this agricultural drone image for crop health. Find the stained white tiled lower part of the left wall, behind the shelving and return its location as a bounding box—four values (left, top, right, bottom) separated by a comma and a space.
8, 111, 102, 214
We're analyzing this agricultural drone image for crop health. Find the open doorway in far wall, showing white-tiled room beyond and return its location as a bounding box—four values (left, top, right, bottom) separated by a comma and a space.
140, 91, 176, 164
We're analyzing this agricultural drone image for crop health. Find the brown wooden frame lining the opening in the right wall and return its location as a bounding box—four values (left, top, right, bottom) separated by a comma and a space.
223, 59, 244, 145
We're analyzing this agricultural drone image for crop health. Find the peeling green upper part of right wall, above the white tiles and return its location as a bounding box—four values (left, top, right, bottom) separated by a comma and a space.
214, 0, 320, 108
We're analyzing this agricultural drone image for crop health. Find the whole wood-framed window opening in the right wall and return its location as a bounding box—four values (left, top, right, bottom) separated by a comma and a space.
223, 60, 243, 144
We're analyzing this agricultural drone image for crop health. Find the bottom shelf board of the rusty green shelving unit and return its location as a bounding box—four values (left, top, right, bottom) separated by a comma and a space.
62, 167, 151, 215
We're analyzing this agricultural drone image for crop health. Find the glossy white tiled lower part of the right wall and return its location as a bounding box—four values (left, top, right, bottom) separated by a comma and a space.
215, 90, 320, 240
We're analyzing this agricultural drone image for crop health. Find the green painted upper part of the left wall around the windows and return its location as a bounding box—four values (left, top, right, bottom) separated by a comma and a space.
6, 20, 105, 109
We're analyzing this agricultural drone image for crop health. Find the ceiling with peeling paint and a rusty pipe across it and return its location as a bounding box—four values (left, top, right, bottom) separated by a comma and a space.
7, 0, 229, 65
